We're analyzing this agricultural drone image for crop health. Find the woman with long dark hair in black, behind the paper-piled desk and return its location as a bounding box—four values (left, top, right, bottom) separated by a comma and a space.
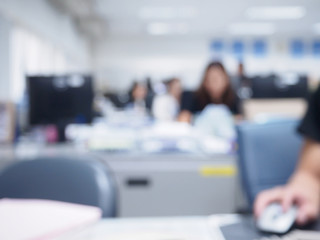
179, 62, 240, 122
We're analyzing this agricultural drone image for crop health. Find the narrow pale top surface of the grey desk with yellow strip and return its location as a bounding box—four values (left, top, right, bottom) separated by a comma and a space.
0, 142, 235, 164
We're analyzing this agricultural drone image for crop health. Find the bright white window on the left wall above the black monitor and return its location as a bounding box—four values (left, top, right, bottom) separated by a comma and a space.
10, 26, 71, 102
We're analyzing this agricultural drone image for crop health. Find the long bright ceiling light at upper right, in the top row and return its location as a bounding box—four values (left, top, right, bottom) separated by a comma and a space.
246, 6, 306, 20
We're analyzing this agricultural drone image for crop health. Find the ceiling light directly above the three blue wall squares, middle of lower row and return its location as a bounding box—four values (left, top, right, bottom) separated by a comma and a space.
229, 22, 275, 35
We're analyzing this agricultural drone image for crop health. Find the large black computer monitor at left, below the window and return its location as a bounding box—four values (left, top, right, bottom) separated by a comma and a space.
27, 74, 94, 129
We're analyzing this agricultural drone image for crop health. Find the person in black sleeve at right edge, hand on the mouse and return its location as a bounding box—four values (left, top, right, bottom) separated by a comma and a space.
254, 88, 320, 225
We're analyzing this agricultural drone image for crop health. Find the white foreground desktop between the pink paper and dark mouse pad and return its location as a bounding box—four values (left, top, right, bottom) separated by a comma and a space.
56, 215, 237, 240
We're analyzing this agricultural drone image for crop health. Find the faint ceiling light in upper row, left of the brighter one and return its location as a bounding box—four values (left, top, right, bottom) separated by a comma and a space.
139, 6, 197, 19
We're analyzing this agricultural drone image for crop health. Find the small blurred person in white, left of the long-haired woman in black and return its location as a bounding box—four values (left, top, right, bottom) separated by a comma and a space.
152, 78, 182, 121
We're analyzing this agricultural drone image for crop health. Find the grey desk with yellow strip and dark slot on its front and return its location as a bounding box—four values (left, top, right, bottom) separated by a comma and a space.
0, 144, 238, 217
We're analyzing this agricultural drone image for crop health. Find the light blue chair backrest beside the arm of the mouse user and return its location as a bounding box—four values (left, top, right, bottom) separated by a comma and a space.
237, 119, 302, 207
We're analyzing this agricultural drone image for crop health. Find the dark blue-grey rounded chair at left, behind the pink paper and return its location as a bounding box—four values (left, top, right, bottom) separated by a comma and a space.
0, 157, 116, 217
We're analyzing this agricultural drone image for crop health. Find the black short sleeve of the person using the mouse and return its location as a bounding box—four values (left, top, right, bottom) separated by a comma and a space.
298, 87, 320, 142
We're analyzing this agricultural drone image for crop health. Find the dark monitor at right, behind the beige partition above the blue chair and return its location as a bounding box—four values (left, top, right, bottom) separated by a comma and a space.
251, 75, 309, 98
